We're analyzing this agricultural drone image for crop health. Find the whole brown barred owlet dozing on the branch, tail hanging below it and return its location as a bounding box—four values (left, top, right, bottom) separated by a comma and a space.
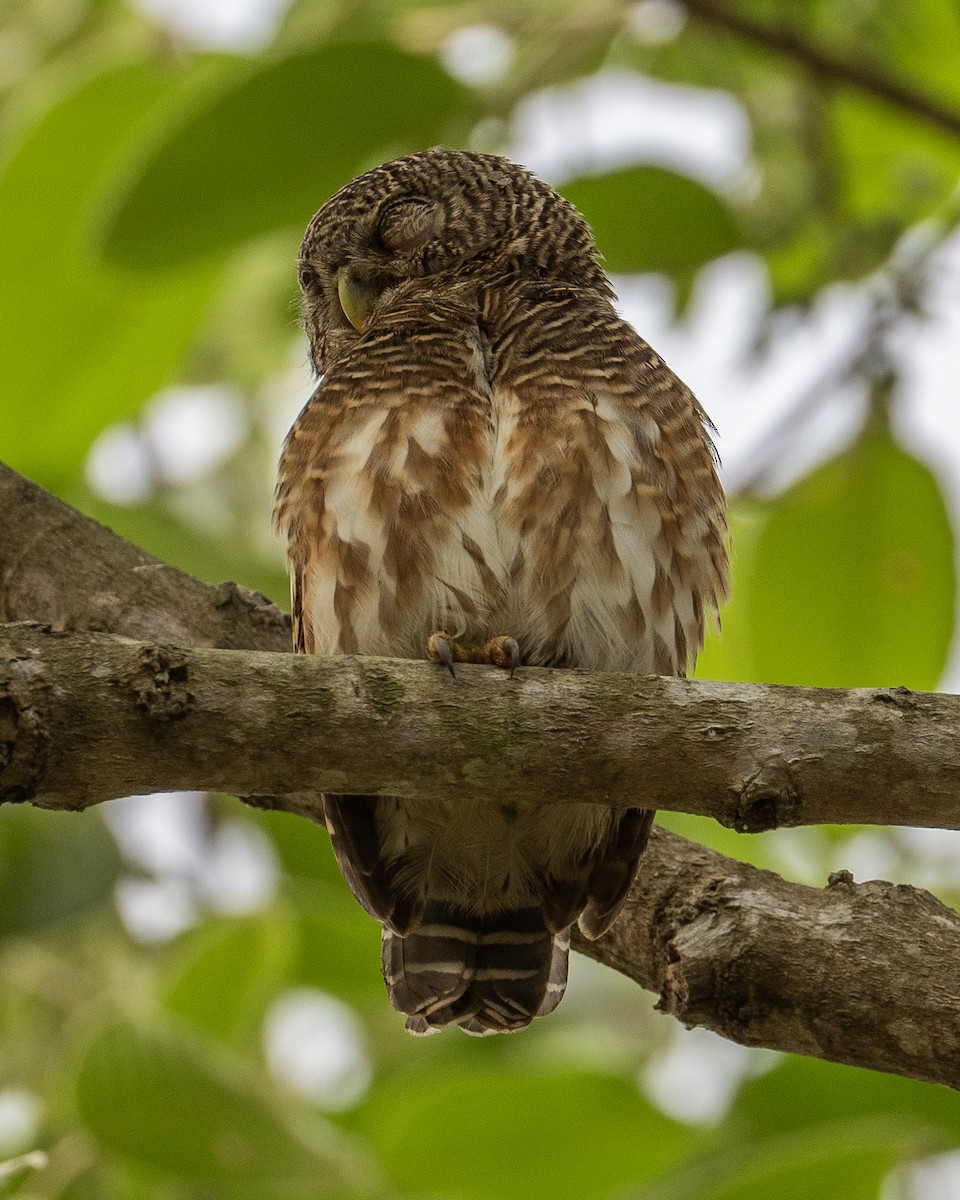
276, 150, 727, 1034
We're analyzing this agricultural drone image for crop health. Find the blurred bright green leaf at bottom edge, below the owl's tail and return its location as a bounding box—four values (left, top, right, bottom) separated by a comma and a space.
348, 1070, 700, 1200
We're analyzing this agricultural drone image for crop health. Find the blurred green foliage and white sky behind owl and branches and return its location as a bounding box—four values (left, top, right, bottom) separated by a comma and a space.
0, 0, 960, 1200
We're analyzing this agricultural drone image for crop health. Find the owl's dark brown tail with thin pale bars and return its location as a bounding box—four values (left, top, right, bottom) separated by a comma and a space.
383, 901, 570, 1037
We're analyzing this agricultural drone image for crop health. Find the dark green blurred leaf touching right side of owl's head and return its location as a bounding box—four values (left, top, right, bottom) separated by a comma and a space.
560, 167, 740, 275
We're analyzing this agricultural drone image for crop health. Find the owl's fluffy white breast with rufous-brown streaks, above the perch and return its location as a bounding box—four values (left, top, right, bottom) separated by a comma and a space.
286, 292, 722, 674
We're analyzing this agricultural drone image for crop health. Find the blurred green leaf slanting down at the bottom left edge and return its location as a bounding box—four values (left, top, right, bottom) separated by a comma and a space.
77, 1021, 380, 1200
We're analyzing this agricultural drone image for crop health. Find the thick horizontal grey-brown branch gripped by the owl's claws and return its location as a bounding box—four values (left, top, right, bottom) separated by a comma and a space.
0, 624, 960, 830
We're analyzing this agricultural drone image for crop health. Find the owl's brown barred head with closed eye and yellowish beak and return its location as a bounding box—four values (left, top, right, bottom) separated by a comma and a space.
299, 149, 610, 373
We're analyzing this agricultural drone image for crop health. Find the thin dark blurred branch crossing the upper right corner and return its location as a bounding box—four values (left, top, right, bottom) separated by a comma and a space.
684, 0, 960, 136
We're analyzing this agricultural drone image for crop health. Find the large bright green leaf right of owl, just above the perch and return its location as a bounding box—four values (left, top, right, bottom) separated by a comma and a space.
745, 425, 956, 690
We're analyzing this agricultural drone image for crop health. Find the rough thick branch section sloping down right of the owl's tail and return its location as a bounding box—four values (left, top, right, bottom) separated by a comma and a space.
574, 829, 960, 1087
